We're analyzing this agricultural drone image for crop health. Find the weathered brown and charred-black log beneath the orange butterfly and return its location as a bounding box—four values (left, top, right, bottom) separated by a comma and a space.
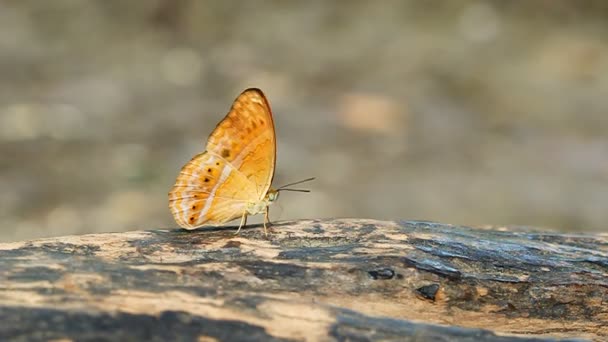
0, 219, 608, 341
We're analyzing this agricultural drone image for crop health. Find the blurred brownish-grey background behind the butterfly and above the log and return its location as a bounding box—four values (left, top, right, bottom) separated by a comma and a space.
0, 0, 608, 241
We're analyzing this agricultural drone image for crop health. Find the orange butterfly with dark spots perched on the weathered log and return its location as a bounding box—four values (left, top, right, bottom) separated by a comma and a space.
169, 88, 314, 234
